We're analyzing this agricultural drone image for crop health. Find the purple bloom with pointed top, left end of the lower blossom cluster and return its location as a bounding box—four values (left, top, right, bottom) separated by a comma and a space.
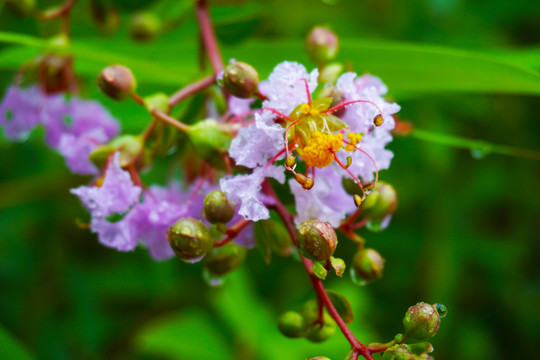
71, 153, 142, 251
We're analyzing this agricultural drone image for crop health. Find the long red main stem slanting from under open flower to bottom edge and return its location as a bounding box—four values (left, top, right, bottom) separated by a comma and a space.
262, 181, 373, 360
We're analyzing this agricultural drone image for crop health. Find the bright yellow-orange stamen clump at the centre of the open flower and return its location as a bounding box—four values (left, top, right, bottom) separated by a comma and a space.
297, 131, 343, 168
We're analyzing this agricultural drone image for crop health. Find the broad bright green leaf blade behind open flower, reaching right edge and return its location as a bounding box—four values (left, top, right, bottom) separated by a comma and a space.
224, 39, 540, 96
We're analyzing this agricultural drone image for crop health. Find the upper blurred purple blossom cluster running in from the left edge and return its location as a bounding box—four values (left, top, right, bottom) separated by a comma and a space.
0, 86, 120, 175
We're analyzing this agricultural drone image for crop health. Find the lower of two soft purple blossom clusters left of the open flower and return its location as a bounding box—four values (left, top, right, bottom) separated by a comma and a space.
71, 153, 254, 260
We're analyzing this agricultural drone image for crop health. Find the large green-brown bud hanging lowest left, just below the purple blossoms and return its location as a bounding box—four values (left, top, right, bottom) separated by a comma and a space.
167, 218, 214, 262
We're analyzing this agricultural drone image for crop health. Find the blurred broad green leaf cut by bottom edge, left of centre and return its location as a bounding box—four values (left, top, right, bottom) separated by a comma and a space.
136, 309, 232, 360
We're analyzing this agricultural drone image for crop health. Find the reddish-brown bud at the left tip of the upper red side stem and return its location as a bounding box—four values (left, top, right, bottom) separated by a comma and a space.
98, 65, 137, 100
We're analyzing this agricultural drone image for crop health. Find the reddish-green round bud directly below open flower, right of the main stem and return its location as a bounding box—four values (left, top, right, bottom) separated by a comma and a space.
297, 220, 337, 261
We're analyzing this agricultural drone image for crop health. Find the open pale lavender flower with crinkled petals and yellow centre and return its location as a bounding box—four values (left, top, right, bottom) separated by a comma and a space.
221, 62, 399, 226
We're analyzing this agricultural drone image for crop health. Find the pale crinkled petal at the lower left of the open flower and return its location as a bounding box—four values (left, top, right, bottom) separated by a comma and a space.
219, 165, 285, 221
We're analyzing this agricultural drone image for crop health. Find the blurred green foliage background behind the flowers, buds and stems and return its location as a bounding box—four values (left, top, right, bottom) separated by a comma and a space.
0, 0, 540, 360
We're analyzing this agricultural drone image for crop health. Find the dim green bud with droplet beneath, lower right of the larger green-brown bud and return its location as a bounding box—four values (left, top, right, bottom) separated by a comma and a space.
203, 243, 247, 276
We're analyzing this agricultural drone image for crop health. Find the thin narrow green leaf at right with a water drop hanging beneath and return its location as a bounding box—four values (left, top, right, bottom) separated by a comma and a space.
409, 129, 540, 160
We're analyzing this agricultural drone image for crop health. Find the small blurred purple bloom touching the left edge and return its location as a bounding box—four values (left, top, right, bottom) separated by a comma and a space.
0, 86, 46, 141
